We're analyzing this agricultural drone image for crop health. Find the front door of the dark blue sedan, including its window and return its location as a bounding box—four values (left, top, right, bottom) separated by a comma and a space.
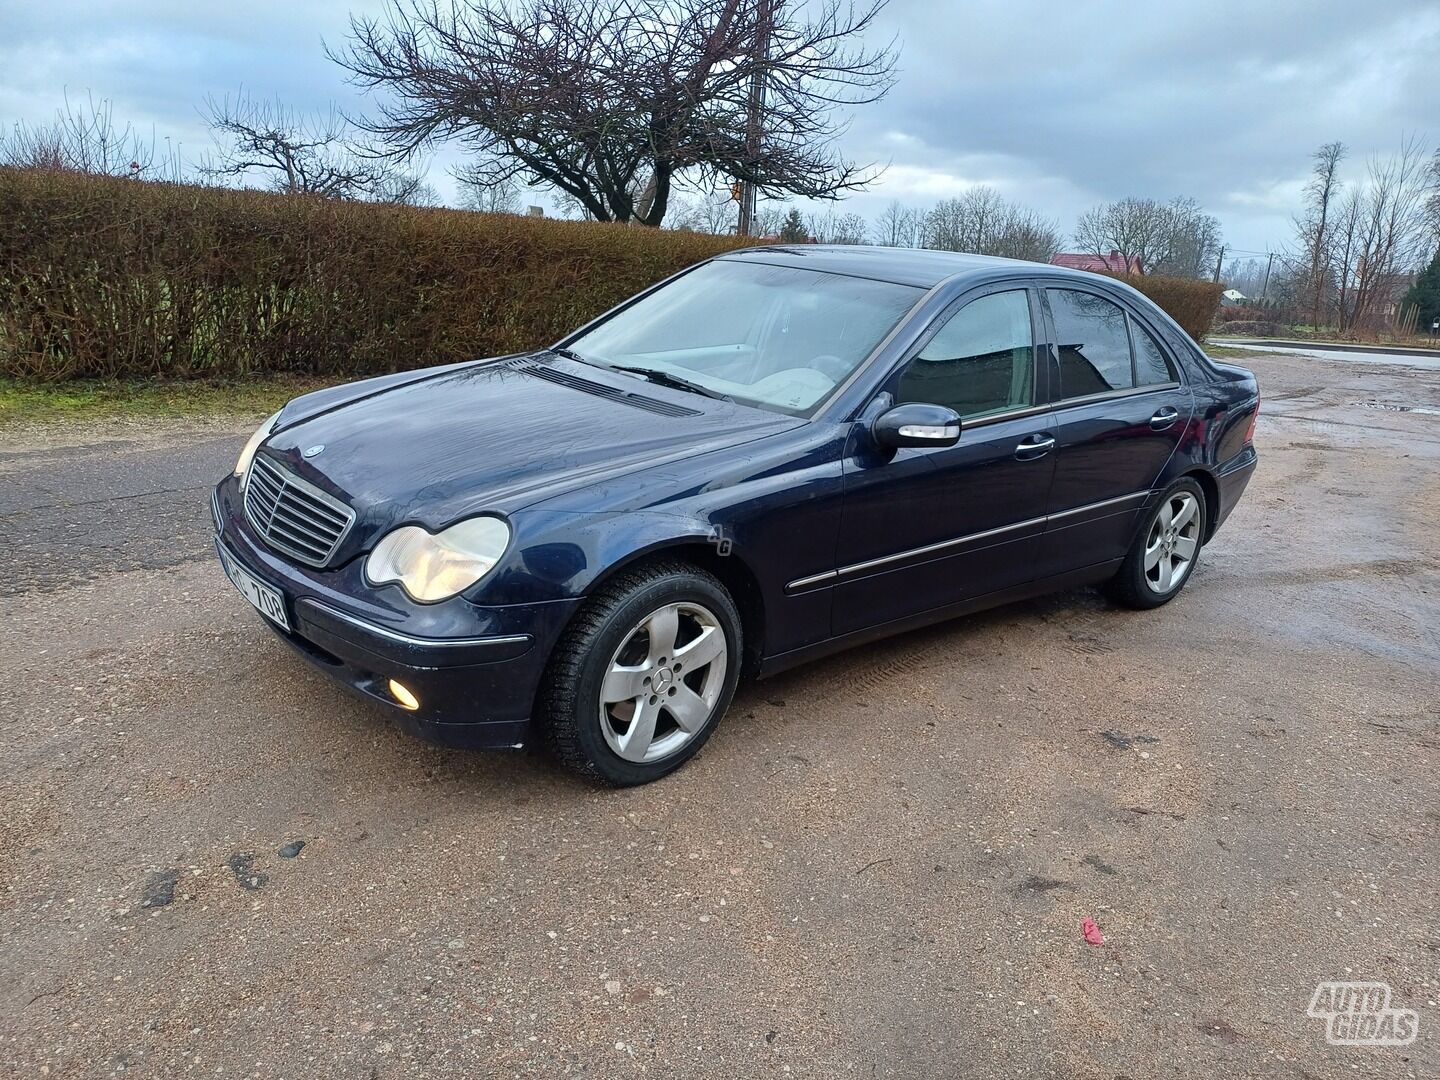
834, 287, 1056, 634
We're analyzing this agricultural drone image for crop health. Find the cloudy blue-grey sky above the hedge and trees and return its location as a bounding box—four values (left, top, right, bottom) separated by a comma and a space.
0, 0, 1440, 252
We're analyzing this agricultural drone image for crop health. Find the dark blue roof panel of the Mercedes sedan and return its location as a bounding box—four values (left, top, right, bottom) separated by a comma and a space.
720, 243, 1094, 288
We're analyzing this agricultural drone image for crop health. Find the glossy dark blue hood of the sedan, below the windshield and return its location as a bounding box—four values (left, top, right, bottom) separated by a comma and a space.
262, 356, 802, 557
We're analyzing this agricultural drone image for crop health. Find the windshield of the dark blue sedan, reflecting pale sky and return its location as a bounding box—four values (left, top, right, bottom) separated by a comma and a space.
569, 259, 923, 416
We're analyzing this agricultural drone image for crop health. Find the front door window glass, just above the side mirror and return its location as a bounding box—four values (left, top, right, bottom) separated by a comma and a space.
896, 289, 1035, 419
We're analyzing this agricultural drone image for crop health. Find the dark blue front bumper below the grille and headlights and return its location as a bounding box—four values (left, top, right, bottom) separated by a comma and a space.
210, 477, 580, 747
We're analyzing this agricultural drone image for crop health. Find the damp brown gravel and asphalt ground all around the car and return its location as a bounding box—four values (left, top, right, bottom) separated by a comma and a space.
0, 356, 1440, 1080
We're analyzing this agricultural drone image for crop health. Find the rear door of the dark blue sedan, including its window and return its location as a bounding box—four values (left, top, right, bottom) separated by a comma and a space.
1038, 282, 1194, 576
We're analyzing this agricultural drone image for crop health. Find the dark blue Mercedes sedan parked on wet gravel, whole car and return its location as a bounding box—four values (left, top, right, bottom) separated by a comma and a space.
213, 246, 1260, 785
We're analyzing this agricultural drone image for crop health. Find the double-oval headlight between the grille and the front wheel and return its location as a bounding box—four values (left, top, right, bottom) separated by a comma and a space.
364, 517, 510, 603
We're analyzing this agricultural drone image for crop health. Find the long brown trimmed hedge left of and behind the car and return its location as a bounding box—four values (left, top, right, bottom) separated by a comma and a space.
0, 168, 746, 380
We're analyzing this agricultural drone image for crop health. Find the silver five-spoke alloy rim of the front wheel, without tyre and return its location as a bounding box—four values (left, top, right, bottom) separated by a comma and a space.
599, 602, 730, 762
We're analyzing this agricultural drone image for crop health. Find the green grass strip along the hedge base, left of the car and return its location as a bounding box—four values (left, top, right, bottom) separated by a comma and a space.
0, 379, 333, 426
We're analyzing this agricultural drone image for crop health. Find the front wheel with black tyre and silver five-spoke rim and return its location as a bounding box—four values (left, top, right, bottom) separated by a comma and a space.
539, 562, 740, 786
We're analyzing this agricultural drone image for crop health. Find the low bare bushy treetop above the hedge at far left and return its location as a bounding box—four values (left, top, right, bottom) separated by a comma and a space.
0, 95, 181, 180
